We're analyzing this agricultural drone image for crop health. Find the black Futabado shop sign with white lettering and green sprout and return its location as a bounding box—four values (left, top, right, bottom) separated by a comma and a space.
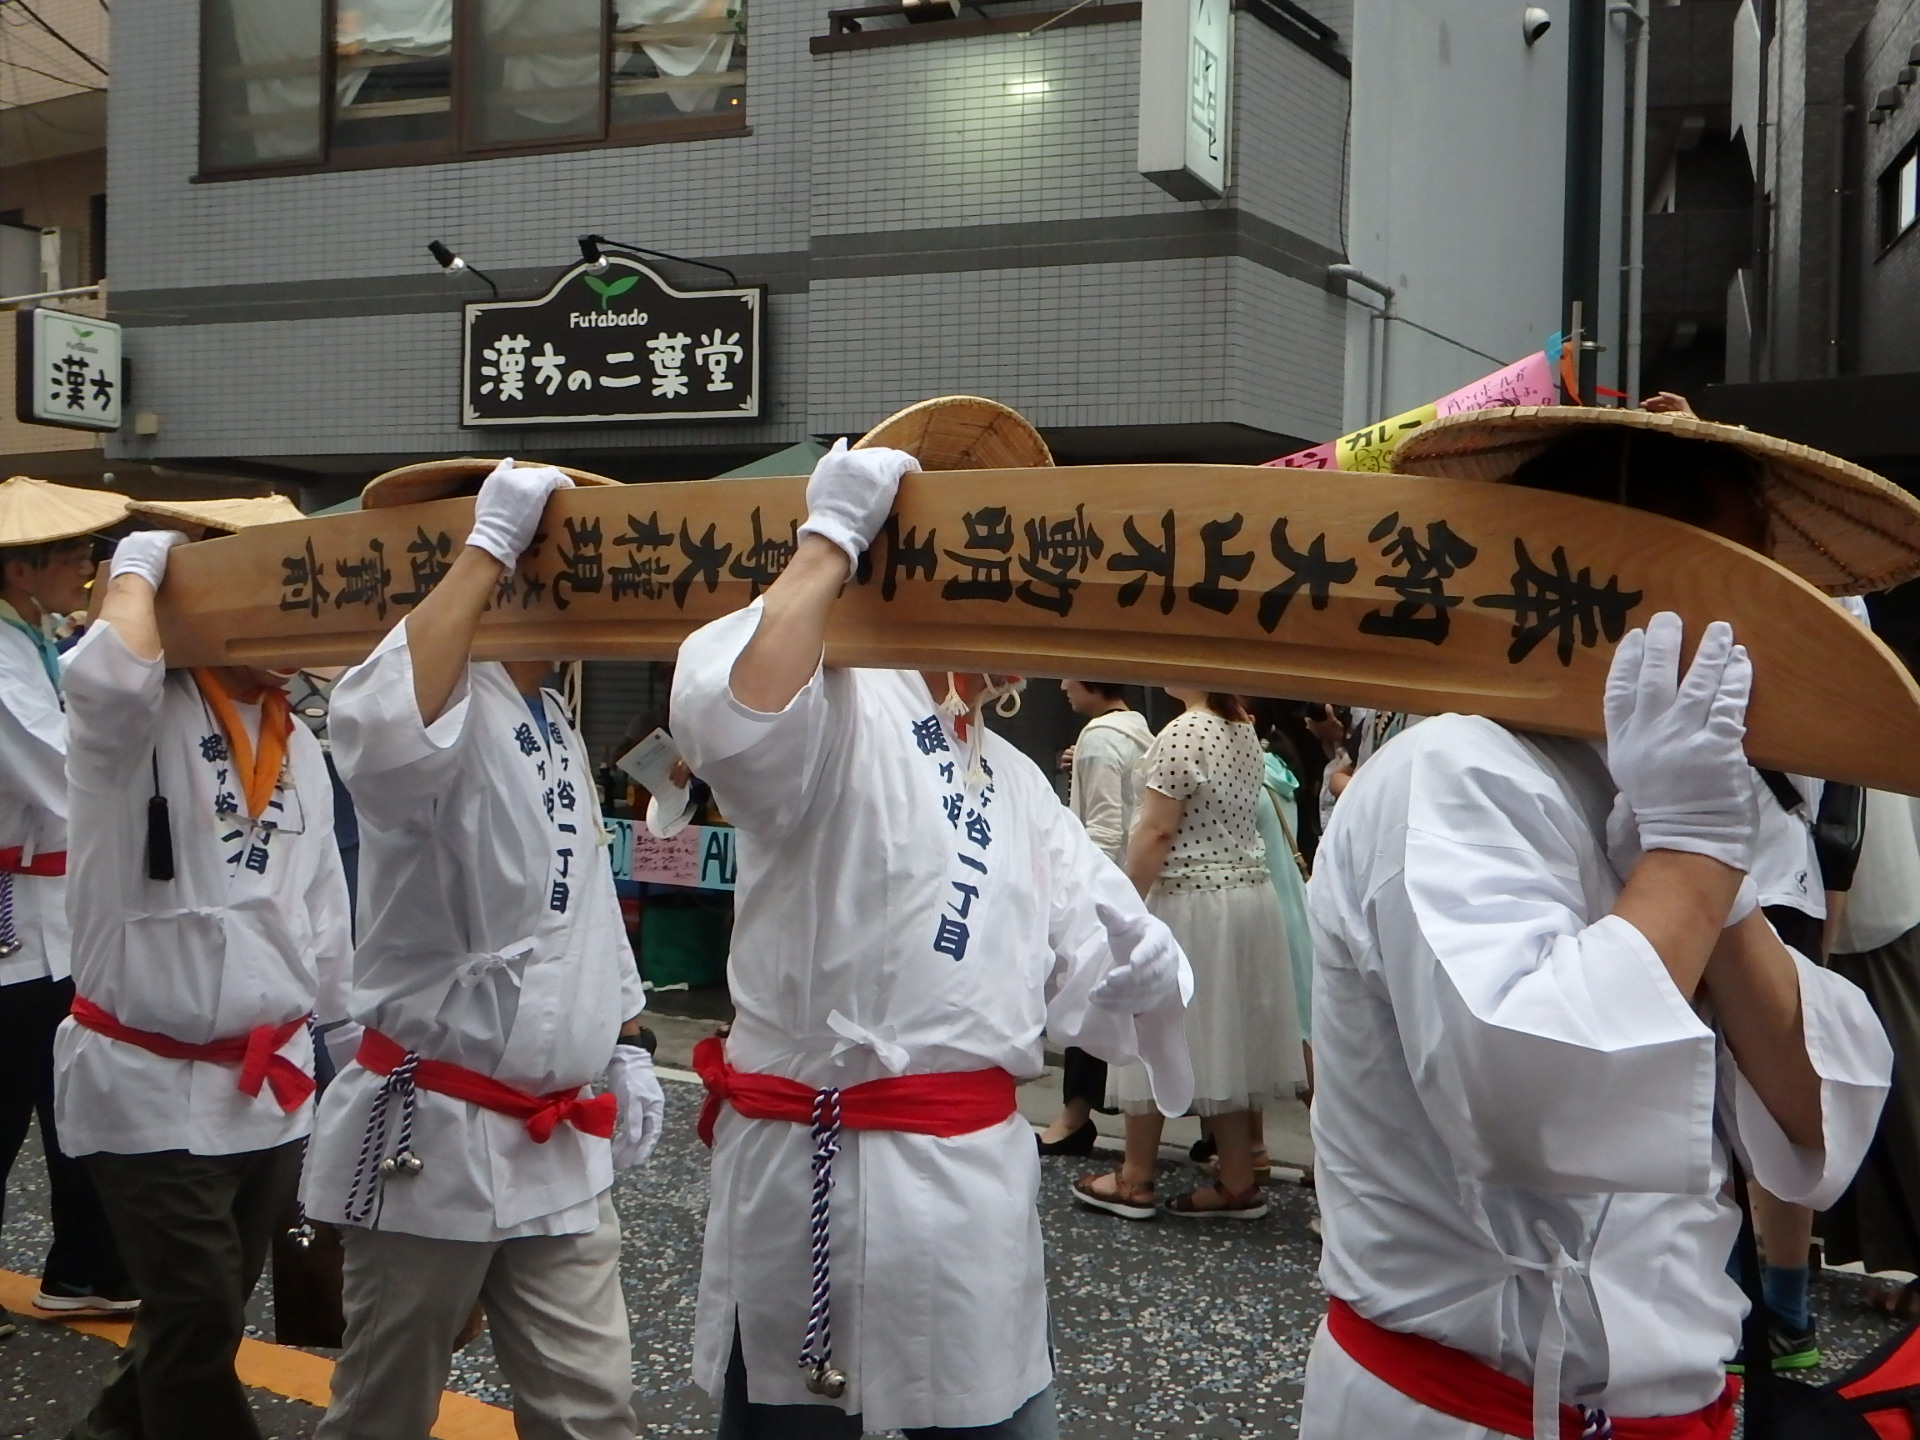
461, 255, 766, 424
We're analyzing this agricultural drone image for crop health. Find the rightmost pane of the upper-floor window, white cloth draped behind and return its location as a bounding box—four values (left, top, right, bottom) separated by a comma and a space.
607, 0, 747, 127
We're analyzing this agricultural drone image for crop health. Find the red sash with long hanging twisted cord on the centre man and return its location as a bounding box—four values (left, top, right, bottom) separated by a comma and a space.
693, 1035, 1018, 1400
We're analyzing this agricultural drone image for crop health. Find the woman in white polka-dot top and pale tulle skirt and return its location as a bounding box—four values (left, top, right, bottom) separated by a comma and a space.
1073, 685, 1306, 1219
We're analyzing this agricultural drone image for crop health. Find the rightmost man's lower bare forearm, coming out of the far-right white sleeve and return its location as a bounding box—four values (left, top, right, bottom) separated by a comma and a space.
1705, 910, 1826, 1150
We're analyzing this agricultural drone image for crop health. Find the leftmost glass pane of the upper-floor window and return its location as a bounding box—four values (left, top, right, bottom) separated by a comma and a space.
200, 0, 326, 169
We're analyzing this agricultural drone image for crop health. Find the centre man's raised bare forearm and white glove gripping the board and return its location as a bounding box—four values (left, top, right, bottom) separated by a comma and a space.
730, 440, 920, 714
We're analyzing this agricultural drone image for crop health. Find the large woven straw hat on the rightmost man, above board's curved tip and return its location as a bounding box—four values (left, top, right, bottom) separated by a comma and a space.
1392, 405, 1920, 595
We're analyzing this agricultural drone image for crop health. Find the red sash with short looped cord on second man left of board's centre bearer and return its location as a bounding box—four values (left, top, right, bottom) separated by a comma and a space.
346, 1029, 620, 1225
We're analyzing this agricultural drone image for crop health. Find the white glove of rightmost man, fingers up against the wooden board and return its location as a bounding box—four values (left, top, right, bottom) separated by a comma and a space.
1605, 611, 1757, 870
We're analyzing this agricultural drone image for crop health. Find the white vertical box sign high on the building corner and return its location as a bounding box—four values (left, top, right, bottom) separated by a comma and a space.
1139, 0, 1233, 200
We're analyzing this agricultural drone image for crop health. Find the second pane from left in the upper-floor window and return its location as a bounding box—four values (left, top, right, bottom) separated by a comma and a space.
336, 0, 453, 152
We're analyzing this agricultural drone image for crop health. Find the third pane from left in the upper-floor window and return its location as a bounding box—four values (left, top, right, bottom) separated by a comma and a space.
470, 0, 605, 144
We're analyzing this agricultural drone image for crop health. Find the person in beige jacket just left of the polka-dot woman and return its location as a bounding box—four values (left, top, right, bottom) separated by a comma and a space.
1039, 680, 1154, 1156
